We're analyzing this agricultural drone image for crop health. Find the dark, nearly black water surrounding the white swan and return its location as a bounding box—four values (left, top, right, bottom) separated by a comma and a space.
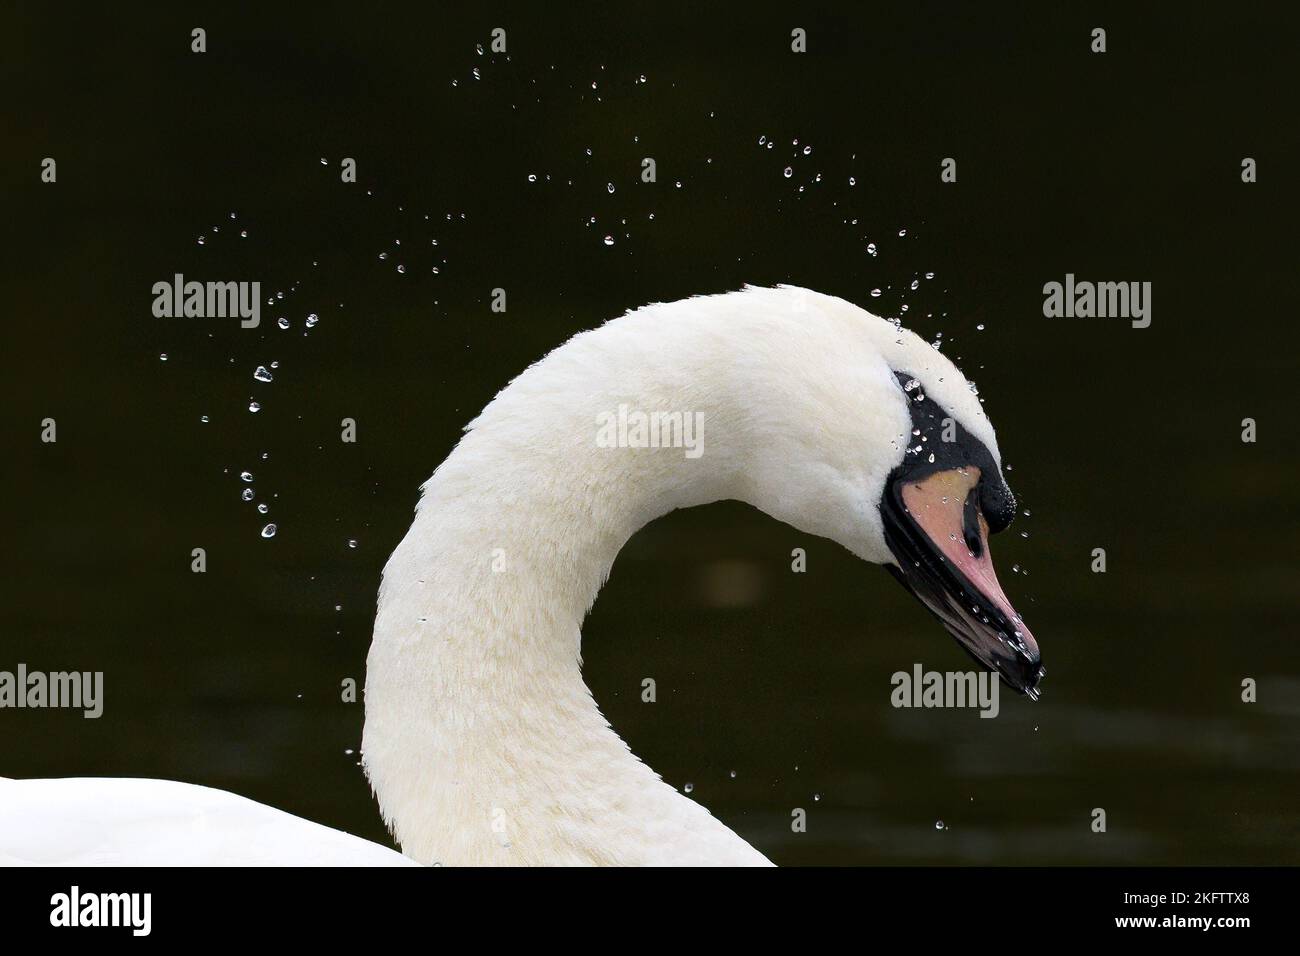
0, 4, 1300, 864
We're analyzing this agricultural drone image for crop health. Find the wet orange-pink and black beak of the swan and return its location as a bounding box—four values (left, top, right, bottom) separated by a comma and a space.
880, 466, 1044, 700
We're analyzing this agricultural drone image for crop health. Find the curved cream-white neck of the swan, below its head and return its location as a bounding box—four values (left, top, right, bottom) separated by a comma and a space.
363, 303, 764, 865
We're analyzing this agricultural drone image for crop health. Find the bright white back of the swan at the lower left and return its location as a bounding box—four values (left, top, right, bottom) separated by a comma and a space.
0, 778, 417, 866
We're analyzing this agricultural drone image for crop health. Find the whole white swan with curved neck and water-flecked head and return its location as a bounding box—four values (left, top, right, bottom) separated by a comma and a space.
0, 286, 1044, 865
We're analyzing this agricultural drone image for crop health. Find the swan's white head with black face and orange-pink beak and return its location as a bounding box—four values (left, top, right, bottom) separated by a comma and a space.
722, 286, 1044, 698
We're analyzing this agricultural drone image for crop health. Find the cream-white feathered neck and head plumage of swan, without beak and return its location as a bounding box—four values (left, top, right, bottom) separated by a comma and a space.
363, 287, 997, 864
